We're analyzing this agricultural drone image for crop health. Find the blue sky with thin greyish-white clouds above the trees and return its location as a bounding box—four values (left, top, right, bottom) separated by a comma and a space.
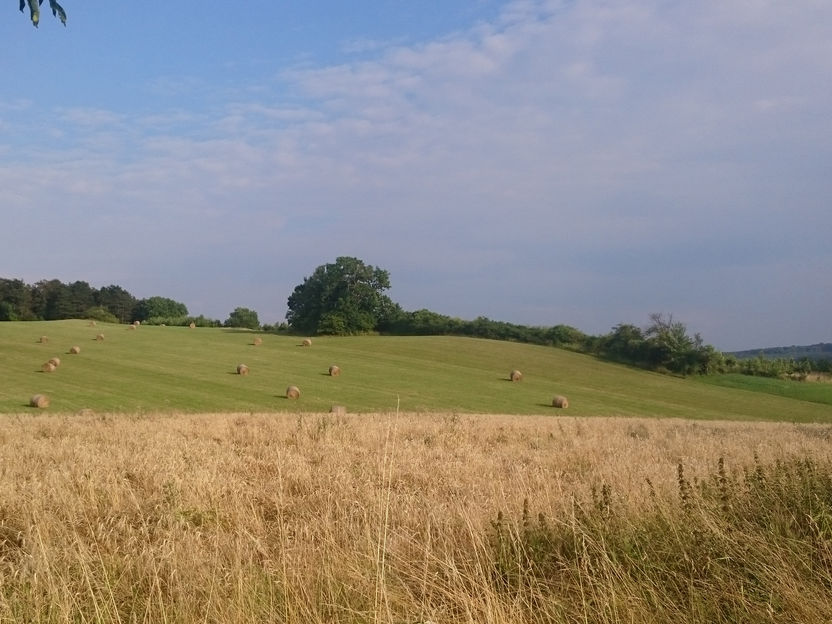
0, 0, 832, 350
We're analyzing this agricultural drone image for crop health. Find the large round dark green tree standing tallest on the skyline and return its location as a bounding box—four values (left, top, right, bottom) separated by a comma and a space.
286, 256, 395, 334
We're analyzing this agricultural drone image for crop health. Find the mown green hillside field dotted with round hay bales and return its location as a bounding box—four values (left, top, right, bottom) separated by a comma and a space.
0, 320, 832, 422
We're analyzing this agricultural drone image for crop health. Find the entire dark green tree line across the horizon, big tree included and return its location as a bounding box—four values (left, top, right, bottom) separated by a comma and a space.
0, 256, 832, 378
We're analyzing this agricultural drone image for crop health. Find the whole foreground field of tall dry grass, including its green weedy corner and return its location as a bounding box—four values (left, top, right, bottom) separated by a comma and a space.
0, 413, 832, 624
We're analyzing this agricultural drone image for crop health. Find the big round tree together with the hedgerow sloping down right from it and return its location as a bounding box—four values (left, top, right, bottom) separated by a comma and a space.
286, 257, 830, 378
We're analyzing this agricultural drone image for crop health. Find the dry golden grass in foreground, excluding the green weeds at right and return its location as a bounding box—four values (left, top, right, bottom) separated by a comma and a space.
0, 413, 832, 624
